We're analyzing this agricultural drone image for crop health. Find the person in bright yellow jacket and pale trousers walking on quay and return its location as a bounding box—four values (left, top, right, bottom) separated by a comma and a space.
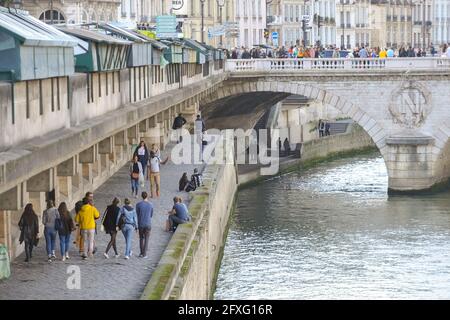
75, 198, 100, 259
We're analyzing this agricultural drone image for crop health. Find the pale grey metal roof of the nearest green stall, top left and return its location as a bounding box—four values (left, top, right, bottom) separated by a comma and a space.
0, 7, 77, 47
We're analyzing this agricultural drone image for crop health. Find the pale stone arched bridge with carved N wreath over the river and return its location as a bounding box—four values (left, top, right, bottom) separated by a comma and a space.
200, 58, 450, 193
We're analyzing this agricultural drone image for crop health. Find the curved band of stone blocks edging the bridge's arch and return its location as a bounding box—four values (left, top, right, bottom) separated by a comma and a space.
200, 78, 388, 159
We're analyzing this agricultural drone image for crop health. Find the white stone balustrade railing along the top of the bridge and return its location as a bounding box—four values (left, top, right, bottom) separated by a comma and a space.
225, 57, 450, 72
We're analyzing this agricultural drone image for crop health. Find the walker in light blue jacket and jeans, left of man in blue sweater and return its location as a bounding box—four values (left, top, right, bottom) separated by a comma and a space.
116, 198, 139, 260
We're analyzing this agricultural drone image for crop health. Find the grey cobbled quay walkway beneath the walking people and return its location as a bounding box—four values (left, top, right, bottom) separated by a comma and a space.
0, 142, 199, 300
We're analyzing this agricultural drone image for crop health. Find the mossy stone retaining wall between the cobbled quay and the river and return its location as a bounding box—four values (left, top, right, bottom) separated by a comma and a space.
141, 158, 237, 300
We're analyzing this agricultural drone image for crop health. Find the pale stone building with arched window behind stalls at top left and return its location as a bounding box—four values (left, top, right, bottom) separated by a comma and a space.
16, 0, 121, 24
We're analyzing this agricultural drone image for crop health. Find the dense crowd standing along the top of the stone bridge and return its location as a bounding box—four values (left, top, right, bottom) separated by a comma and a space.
228, 44, 450, 59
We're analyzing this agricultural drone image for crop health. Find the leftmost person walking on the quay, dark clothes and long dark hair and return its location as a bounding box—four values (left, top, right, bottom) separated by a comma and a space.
19, 203, 39, 262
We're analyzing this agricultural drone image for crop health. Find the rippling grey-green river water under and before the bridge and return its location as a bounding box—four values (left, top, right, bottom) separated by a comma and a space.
215, 155, 450, 299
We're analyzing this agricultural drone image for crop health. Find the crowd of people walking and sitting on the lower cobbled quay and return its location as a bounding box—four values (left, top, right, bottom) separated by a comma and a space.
18, 114, 209, 262
